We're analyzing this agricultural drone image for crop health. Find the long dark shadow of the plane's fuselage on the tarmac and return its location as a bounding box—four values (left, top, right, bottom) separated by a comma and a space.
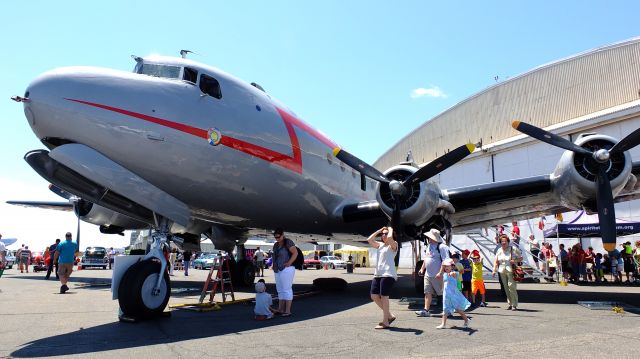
10, 278, 376, 358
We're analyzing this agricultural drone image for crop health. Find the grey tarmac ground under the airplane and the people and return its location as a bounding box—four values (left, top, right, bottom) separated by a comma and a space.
0, 267, 640, 359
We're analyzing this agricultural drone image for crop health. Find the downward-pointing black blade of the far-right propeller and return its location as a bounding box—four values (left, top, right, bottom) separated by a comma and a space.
596, 166, 616, 251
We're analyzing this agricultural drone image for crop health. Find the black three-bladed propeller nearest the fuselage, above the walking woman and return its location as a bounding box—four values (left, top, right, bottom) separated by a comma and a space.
333, 143, 475, 240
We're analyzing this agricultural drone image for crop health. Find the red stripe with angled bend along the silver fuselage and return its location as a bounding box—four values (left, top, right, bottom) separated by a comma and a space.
65, 98, 338, 173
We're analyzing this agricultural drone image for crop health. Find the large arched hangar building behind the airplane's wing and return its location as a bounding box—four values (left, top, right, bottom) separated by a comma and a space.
374, 38, 640, 264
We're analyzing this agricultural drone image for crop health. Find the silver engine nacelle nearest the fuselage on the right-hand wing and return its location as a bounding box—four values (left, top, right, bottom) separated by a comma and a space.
376, 165, 442, 226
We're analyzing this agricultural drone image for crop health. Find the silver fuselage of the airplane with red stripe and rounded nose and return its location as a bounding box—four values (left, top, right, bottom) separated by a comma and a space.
25, 58, 375, 234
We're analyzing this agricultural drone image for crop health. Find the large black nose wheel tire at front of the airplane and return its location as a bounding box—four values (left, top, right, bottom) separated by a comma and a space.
118, 259, 171, 318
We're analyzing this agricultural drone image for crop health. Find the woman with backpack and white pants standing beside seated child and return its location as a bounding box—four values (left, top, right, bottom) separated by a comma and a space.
273, 228, 298, 317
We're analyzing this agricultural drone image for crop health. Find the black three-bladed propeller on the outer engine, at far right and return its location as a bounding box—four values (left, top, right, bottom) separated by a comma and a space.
511, 121, 640, 251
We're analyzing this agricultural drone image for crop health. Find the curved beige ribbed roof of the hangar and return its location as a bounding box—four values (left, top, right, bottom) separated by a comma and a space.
374, 37, 640, 170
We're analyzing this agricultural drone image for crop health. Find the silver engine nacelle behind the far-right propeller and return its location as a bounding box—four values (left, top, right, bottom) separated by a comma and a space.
551, 134, 632, 212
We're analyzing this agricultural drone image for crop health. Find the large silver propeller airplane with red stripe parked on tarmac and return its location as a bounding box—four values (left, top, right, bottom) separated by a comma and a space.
10, 54, 640, 317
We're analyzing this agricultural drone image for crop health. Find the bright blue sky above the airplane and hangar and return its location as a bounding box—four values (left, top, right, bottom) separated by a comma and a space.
0, 0, 640, 253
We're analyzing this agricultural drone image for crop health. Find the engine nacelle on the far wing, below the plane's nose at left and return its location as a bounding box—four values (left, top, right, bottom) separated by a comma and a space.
73, 199, 149, 233
